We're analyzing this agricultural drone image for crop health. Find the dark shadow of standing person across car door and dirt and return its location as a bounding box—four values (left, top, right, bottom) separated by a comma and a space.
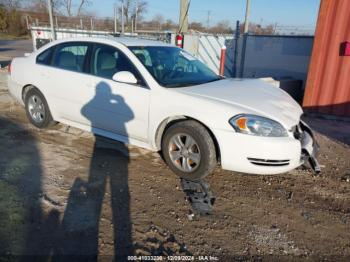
56, 82, 134, 261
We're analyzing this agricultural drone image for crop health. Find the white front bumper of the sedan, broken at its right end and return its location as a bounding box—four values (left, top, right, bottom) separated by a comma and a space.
214, 123, 318, 175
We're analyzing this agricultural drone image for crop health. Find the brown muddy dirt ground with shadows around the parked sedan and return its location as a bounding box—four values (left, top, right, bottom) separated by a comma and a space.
0, 70, 350, 261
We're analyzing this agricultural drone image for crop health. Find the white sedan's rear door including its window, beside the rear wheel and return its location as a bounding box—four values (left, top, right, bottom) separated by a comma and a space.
37, 42, 95, 125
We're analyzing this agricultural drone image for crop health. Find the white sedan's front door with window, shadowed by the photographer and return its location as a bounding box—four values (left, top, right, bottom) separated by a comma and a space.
77, 44, 150, 141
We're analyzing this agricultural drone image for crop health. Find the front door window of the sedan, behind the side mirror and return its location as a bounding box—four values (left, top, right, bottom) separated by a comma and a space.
90, 44, 144, 85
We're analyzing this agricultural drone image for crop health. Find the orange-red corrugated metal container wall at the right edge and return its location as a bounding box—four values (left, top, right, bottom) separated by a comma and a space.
303, 0, 350, 116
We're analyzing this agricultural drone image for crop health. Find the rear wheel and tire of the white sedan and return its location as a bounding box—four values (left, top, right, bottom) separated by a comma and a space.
24, 88, 56, 128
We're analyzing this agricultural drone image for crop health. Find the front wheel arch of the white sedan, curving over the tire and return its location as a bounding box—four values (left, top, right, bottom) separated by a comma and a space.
155, 115, 221, 160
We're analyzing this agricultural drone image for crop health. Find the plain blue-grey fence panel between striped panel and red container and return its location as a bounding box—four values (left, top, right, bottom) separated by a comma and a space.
225, 35, 314, 82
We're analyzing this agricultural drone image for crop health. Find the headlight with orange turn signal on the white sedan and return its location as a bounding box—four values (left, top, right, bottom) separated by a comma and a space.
229, 115, 288, 137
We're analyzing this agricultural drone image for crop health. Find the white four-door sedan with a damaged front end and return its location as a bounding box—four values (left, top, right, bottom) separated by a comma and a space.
9, 37, 317, 180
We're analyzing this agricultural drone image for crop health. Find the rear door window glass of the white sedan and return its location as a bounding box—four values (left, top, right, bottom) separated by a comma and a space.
53, 43, 88, 72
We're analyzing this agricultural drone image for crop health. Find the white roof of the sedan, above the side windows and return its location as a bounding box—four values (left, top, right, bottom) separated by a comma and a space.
50, 36, 174, 46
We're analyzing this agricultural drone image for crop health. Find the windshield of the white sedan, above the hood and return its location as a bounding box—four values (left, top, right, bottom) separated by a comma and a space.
129, 46, 221, 87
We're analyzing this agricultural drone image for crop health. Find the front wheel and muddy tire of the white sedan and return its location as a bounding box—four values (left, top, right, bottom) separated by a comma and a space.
162, 120, 217, 181
